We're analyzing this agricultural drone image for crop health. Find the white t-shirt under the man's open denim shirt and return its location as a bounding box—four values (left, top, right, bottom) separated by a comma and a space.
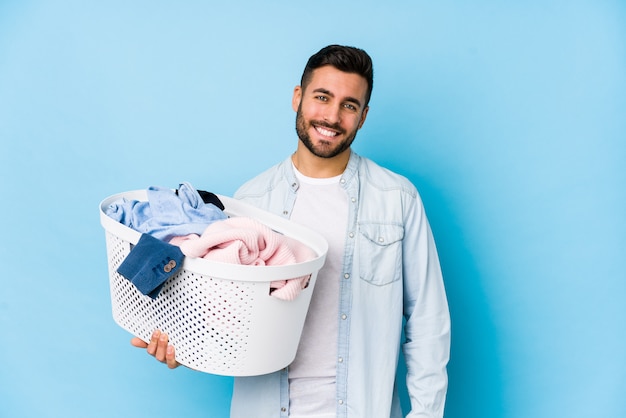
289, 167, 348, 418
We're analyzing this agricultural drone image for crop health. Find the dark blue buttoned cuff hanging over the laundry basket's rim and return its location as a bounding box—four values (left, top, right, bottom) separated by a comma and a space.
117, 234, 185, 299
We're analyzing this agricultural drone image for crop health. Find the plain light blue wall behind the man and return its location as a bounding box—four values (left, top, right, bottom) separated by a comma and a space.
0, 0, 626, 418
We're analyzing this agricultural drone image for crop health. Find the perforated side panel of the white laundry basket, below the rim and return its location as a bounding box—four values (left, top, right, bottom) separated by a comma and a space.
107, 233, 255, 374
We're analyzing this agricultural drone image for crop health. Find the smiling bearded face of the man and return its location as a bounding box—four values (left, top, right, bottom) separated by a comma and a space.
292, 65, 368, 158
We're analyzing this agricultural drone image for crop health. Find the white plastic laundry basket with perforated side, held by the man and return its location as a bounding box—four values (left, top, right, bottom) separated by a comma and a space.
100, 190, 328, 376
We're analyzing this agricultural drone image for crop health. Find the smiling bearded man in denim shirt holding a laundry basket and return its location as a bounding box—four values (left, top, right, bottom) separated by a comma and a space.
133, 45, 450, 418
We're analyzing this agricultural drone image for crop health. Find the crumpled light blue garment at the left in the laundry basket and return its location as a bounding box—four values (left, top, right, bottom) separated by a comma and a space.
106, 183, 227, 242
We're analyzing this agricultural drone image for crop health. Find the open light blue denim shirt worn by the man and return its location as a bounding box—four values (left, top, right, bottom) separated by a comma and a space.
231, 152, 450, 418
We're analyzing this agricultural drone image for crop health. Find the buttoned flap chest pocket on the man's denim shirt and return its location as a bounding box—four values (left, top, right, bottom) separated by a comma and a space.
358, 222, 404, 286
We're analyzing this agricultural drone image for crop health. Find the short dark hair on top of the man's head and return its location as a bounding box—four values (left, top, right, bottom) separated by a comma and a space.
300, 45, 374, 106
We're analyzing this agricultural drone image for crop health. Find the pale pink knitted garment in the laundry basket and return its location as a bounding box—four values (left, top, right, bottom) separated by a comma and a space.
170, 217, 316, 300
